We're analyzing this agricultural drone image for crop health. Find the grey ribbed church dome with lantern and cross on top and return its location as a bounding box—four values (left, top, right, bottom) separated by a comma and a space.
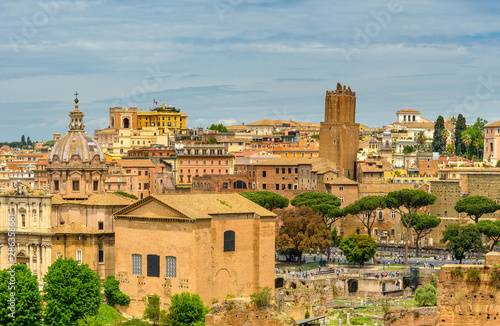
49, 98, 104, 162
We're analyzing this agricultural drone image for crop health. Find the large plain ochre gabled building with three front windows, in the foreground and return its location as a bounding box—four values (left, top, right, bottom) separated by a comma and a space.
114, 194, 276, 316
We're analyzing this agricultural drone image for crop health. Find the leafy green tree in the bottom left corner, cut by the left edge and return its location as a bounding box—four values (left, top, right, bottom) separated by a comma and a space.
0, 264, 42, 326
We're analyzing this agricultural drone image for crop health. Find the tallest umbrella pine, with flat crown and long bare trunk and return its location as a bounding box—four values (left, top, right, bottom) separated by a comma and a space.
385, 189, 437, 265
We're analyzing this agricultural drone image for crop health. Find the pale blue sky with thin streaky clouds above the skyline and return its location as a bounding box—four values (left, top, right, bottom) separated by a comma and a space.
0, 0, 500, 141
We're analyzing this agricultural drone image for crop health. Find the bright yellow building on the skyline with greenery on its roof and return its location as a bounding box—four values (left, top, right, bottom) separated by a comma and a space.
137, 104, 187, 135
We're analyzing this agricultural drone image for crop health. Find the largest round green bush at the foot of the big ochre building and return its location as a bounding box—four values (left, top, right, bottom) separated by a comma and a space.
161, 292, 210, 326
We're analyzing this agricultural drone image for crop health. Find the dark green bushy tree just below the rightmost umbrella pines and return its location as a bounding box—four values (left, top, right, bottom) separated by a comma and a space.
440, 223, 483, 264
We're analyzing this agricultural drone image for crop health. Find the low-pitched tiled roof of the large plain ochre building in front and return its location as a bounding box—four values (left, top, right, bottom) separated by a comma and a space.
113, 193, 276, 219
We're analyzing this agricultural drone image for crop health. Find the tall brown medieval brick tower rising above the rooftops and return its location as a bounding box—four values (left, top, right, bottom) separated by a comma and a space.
319, 83, 359, 178
